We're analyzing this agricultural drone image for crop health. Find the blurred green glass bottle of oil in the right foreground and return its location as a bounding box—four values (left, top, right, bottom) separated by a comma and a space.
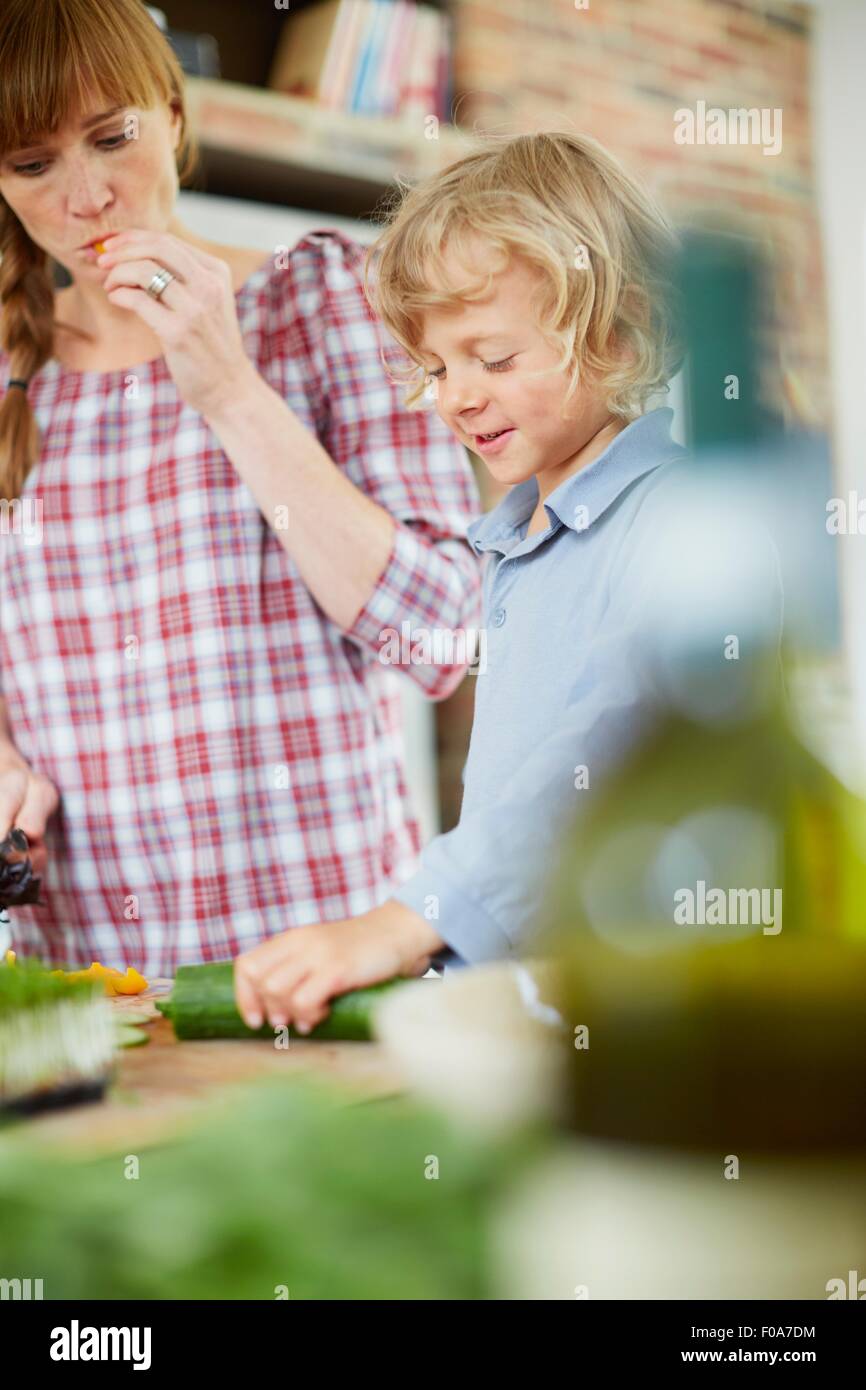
544, 240, 866, 1154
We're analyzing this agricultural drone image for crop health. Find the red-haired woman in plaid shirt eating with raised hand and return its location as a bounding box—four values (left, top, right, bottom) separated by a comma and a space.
0, 0, 478, 976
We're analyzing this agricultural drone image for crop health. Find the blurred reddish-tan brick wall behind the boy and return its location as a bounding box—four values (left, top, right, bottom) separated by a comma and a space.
439, 0, 822, 826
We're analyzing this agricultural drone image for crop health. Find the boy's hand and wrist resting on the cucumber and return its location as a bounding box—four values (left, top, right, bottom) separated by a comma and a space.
235, 898, 445, 1033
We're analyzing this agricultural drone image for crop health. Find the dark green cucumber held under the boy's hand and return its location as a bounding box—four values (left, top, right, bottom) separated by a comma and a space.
156, 960, 406, 1043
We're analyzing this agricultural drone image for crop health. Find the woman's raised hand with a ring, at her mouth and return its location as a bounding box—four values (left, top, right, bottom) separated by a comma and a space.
99, 231, 256, 418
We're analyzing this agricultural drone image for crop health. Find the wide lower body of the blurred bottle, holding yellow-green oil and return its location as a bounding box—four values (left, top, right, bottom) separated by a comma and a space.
546, 689, 866, 1152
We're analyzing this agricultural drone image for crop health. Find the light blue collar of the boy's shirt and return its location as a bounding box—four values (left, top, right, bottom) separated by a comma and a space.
467, 406, 685, 555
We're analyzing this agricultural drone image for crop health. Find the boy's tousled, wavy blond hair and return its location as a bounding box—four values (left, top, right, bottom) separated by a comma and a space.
366, 132, 683, 420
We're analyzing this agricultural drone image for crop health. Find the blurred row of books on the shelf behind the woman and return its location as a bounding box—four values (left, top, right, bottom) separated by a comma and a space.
268, 0, 450, 120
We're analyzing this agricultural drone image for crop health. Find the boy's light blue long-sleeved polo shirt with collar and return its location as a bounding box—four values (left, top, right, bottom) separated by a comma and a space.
395, 407, 687, 962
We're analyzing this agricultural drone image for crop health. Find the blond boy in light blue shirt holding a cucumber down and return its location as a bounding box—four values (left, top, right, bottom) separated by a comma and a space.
235, 133, 684, 1031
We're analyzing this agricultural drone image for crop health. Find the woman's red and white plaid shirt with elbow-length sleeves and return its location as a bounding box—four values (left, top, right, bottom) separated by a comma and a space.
0, 232, 480, 976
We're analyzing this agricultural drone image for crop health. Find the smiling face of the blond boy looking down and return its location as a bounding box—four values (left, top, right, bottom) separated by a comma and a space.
418, 243, 612, 495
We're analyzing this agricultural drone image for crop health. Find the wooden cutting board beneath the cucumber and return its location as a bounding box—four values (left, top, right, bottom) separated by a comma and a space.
13, 980, 403, 1154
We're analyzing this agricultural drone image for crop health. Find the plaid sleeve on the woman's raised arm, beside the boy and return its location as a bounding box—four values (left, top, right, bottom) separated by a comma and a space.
287, 232, 481, 699
